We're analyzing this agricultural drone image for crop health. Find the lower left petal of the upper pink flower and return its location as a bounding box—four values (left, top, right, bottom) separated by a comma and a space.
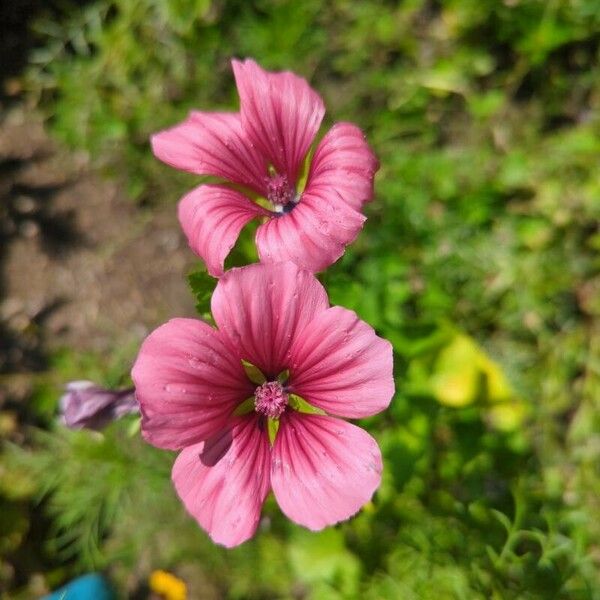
179, 185, 269, 277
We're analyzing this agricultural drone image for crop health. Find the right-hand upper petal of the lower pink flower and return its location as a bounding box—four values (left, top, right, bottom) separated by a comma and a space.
289, 306, 394, 418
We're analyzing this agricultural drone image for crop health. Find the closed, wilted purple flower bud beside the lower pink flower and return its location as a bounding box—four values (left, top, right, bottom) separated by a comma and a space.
60, 381, 140, 431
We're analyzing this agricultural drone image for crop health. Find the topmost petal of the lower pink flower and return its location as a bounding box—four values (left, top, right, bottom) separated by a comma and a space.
212, 263, 329, 378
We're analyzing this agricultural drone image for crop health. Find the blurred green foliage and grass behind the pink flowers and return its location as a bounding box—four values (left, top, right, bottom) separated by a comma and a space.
0, 0, 600, 600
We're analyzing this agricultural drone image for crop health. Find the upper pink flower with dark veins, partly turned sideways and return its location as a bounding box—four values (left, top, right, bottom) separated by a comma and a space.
152, 59, 378, 277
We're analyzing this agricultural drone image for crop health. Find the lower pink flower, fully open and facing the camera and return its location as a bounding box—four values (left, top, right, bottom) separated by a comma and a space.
132, 262, 394, 546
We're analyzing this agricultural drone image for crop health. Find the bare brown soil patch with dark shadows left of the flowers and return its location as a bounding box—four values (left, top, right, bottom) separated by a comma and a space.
0, 109, 194, 372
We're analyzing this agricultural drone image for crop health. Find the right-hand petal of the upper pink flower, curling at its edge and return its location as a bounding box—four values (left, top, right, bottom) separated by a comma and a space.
306, 123, 379, 210
